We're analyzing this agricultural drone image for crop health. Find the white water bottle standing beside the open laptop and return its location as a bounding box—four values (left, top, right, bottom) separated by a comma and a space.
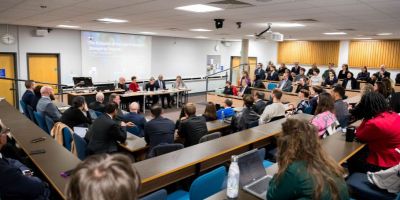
226, 156, 240, 199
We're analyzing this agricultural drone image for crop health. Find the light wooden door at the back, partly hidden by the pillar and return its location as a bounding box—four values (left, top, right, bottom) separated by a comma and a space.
231, 56, 257, 85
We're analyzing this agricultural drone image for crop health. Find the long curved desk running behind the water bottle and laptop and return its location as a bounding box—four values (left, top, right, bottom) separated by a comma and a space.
133, 114, 312, 195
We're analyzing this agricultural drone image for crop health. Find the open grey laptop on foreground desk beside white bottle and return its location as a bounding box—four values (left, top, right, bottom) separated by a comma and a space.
238, 149, 272, 199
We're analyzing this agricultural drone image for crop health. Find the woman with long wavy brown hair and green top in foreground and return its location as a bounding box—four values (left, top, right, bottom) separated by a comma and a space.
267, 118, 349, 200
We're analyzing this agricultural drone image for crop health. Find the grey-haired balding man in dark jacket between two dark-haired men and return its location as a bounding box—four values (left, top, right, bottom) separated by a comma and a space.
123, 102, 147, 137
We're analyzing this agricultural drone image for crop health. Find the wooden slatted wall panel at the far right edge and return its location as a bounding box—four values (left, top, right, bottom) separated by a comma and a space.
349, 40, 400, 69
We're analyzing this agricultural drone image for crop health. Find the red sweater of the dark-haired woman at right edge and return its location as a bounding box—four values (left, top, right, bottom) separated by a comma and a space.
356, 112, 400, 168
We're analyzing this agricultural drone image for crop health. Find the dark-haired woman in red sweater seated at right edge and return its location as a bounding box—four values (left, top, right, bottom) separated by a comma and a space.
355, 92, 400, 172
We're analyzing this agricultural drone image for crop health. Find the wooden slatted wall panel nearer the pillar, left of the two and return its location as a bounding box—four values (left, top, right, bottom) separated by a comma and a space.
278, 41, 340, 65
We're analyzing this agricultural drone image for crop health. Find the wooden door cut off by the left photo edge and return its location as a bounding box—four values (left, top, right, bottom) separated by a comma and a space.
0, 53, 16, 106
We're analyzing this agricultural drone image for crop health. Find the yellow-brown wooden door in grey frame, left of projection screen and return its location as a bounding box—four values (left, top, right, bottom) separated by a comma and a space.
27, 53, 60, 94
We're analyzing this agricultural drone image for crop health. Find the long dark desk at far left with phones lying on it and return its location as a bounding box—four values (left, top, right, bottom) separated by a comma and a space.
0, 101, 80, 199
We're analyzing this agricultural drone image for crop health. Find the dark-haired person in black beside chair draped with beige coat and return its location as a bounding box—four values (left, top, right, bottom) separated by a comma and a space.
60, 96, 92, 129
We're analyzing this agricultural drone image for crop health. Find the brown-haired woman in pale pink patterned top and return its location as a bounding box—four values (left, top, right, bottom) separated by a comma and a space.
311, 92, 337, 137
